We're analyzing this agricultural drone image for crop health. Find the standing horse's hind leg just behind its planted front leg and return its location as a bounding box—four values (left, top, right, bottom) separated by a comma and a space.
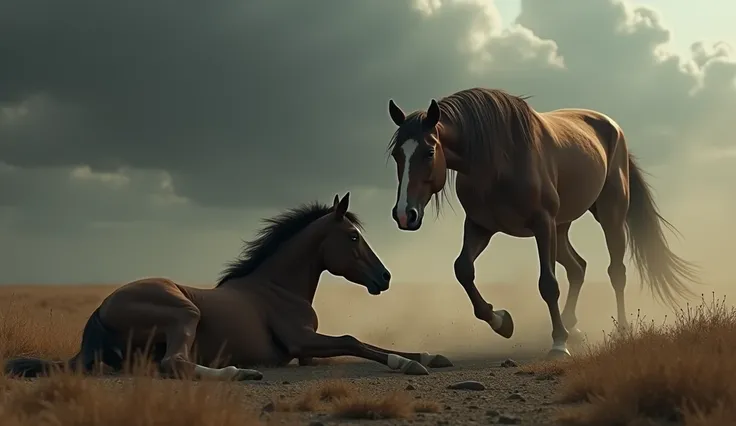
557, 222, 588, 339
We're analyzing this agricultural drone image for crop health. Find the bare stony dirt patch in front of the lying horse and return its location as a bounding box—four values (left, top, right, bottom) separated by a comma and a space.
246, 359, 558, 425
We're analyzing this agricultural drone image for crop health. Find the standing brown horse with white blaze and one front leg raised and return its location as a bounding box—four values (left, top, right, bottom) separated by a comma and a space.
389, 88, 697, 357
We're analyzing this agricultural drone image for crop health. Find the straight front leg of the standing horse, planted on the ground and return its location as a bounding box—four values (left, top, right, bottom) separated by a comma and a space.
530, 211, 570, 358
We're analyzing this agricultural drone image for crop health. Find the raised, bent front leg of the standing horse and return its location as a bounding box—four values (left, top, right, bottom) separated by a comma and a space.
454, 217, 514, 339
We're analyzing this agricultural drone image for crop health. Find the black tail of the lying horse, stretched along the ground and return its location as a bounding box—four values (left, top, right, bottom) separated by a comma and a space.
4, 310, 123, 377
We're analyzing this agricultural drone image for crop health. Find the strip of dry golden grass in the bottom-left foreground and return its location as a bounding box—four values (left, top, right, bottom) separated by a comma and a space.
0, 373, 261, 426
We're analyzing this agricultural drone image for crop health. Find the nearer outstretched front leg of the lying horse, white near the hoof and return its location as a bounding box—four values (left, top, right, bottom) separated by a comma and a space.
285, 331, 429, 375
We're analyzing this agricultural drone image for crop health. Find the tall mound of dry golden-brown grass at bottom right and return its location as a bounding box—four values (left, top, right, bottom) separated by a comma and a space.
527, 296, 736, 426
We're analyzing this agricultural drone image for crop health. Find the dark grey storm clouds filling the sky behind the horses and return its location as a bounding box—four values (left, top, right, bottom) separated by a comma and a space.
0, 0, 736, 279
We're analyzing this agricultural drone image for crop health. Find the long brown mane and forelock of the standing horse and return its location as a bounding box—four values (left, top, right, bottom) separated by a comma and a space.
388, 87, 539, 201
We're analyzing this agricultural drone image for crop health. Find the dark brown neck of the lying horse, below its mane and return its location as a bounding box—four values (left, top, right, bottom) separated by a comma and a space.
250, 230, 325, 304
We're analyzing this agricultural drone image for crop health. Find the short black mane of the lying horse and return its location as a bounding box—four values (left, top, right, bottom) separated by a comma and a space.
217, 201, 363, 286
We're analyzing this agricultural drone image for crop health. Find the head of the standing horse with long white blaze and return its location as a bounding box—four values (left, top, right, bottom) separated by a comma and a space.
388, 99, 447, 231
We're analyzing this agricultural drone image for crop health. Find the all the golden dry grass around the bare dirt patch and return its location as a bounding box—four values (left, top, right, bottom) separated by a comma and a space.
0, 286, 736, 426
